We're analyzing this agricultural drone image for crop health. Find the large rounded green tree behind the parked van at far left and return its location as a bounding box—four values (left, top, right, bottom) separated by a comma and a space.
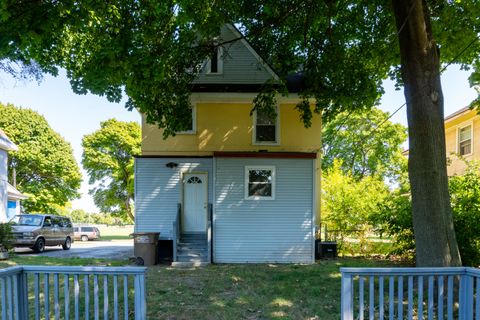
0, 104, 82, 212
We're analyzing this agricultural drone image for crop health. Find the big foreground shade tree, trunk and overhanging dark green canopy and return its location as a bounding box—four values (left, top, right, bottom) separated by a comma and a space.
0, 0, 480, 266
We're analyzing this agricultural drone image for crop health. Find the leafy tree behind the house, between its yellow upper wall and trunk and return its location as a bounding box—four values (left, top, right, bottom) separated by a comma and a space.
322, 108, 407, 180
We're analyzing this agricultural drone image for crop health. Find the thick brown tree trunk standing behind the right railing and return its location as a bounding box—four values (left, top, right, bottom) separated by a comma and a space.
392, 0, 461, 267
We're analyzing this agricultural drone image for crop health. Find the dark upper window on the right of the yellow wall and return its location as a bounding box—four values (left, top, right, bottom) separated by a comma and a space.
254, 108, 279, 144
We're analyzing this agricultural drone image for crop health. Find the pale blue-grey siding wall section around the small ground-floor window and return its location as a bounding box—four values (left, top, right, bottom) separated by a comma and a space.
214, 158, 314, 263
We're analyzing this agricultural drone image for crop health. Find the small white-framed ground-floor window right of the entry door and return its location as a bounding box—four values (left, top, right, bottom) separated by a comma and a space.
245, 166, 275, 200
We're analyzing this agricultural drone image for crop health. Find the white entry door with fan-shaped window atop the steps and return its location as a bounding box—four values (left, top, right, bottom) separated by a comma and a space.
182, 173, 208, 233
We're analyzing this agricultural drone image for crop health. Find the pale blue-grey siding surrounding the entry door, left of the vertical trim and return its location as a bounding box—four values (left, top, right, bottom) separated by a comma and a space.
135, 158, 213, 239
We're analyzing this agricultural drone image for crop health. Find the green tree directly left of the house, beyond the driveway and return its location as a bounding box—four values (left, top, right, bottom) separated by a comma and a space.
82, 119, 142, 221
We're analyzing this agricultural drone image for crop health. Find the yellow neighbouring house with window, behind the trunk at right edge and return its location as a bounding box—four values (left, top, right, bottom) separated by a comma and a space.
445, 107, 480, 176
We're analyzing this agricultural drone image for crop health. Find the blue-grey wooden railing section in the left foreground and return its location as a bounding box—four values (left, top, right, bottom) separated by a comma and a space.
0, 266, 147, 320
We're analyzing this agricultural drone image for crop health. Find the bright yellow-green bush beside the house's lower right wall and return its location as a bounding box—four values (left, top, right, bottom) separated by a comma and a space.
322, 160, 388, 254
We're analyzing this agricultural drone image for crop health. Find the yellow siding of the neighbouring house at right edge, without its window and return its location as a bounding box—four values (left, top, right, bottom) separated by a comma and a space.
445, 110, 480, 176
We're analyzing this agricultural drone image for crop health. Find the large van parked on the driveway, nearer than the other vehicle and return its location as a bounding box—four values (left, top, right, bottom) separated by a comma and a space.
10, 214, 73, 253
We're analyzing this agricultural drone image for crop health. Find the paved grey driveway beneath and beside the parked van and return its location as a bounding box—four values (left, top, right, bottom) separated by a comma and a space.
15, 240, 133, 260
